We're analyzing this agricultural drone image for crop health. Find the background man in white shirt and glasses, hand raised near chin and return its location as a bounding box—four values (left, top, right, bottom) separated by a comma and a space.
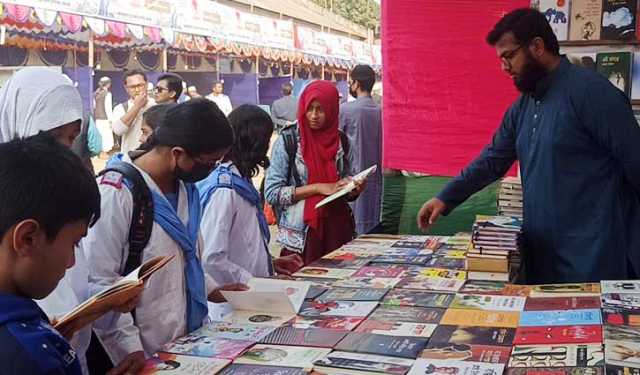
112, 70, 155, 153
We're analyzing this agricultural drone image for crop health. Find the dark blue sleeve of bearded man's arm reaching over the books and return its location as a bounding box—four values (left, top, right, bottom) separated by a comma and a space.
438, 100, 520, 215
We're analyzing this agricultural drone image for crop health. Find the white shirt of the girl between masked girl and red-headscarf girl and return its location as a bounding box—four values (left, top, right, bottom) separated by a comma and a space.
200, 163, 271, 285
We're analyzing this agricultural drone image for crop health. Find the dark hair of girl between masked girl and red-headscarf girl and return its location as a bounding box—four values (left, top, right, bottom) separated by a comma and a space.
229, 104, 273, 178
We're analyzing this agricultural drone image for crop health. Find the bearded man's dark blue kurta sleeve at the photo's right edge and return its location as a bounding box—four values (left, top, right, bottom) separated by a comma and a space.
579, 80, 640, 194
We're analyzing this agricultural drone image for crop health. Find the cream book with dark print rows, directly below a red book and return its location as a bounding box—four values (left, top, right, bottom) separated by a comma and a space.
509, 344, 604, 367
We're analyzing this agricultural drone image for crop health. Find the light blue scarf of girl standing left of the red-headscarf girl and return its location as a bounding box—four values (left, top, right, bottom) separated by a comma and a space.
196, 165, 273, 275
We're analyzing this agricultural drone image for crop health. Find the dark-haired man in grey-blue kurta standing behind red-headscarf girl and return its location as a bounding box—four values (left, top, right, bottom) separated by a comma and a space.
340, 65, 382, 234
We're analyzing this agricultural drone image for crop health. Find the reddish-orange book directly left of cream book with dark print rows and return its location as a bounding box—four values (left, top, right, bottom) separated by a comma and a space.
420, 343, 511, 364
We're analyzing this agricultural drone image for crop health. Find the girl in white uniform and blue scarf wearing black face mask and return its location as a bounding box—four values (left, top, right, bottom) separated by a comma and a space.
83, 100, 245, 374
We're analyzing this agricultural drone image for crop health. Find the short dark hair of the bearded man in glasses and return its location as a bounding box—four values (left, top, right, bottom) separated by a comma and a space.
487, 8, 560, 56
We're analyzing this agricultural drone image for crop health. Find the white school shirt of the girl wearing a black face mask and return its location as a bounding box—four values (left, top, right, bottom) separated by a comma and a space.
83, 155, 217, 363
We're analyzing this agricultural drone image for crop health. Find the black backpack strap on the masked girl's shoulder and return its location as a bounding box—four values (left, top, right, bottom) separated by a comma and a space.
99, 162, 153, 276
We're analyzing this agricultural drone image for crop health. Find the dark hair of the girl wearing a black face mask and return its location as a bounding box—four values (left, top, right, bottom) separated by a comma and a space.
147, 98, 233, 156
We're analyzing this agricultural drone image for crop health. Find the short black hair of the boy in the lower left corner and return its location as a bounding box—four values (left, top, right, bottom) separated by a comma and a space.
0, 133, 100, 241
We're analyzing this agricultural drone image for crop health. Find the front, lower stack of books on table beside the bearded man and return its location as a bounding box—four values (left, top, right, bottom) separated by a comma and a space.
466, 215, 522, 281
